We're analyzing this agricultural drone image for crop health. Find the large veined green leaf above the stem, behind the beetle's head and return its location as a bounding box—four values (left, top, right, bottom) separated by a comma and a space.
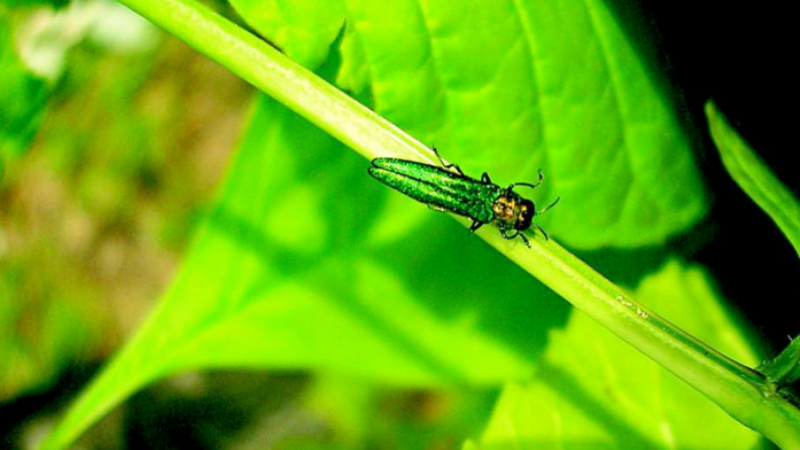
234, 0, 707, 248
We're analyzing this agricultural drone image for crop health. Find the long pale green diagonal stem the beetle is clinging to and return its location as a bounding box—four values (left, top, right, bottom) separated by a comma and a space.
62, 0, 800, 449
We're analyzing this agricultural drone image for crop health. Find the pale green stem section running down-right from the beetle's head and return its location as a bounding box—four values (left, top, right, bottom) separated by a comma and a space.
482, 233, 800, 449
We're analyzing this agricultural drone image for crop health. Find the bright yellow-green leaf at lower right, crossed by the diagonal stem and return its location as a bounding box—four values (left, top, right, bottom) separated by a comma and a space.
474, 261, 758, 450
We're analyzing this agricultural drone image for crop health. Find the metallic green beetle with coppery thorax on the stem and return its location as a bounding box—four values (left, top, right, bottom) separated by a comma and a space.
368, 148, 560, 247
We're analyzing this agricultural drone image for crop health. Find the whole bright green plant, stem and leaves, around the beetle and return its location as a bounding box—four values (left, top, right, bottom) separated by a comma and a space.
1, 0, 800, 448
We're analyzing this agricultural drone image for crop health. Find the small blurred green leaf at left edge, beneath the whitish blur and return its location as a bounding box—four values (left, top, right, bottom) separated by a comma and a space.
0, 10, 50, 166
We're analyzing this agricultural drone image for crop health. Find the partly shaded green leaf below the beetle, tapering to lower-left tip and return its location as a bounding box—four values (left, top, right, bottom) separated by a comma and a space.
42, 94, 567, 448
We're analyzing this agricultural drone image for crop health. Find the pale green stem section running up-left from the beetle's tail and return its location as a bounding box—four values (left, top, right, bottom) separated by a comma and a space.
119, 0, 435, 162
